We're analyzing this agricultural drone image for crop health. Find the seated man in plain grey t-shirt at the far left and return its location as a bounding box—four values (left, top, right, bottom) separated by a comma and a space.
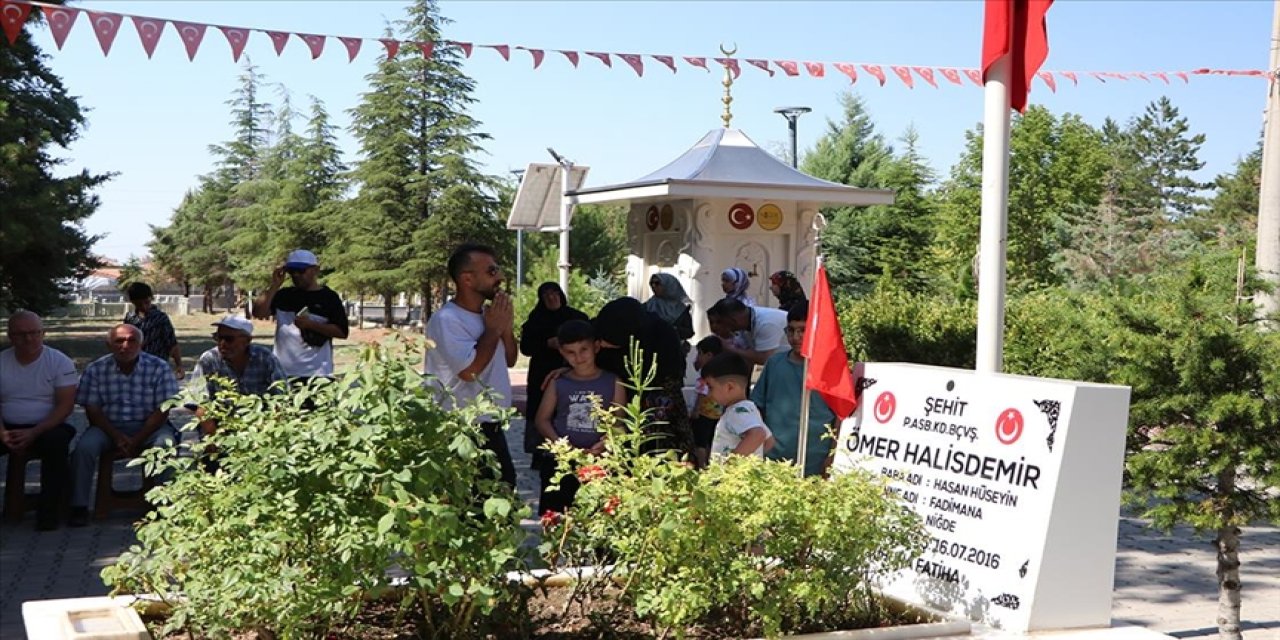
0, 311, 79, 531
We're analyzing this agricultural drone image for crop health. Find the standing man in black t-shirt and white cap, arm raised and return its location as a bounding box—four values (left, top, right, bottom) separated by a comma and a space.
253, 248, 348, 378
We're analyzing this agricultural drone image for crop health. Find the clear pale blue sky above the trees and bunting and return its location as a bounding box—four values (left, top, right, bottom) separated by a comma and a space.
36, 0, 1272, 260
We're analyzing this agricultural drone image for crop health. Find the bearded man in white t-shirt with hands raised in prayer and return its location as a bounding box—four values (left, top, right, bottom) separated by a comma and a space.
424, 243, 516, 488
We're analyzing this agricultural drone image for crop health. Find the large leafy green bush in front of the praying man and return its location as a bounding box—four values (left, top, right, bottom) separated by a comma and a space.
102, 337, 525, 637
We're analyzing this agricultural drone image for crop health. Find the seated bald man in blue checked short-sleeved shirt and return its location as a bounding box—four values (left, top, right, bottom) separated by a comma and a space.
67, 324, 178, 526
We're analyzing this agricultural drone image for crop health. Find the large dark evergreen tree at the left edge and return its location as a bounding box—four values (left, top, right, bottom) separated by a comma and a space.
0, 10, 110, 312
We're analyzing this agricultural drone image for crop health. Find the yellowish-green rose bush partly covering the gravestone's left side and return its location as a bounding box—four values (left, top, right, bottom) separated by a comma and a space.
541, 351, 927, 636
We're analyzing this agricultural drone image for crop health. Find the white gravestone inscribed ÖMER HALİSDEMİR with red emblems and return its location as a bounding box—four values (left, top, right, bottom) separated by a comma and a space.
835, 364, 1129, 632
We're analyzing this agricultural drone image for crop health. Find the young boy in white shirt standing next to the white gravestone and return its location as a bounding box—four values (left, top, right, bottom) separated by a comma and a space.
701, 352, 773, 460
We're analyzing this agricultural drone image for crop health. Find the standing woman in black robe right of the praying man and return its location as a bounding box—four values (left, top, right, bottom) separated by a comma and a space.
520, 282, 589, 468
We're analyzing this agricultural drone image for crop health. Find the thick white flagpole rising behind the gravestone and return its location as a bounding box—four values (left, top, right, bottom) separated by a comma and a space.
975, 55, 1010, 372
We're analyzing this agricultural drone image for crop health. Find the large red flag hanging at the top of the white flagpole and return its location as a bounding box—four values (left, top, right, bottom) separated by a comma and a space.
982, 0, 1053, 113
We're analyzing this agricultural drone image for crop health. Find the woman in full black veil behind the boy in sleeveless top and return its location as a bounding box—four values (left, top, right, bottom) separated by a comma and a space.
593, 298, 694, 457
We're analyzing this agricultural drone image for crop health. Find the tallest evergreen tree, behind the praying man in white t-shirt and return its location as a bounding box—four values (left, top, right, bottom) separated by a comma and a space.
333, 0, 511, 322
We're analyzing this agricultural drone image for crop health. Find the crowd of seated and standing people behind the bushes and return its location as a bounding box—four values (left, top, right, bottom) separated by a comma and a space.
0, 244, 835, 530
